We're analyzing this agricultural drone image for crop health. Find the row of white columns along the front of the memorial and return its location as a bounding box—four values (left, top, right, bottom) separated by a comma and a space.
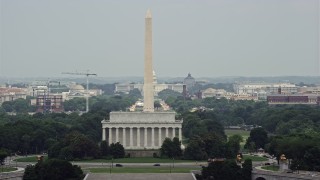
102, 127, 182, 149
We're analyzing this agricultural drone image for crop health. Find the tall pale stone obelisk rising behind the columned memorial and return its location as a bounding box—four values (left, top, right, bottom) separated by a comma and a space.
143, 9, 154, 112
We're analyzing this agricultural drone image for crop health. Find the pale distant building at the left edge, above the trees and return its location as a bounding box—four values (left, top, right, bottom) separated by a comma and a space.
0, 87, 27, 105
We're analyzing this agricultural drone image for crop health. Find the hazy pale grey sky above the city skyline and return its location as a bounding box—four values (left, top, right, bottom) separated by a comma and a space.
0, 0, 320, 77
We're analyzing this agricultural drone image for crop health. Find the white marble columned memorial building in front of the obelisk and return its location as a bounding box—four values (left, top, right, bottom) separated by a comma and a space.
101, 112, 183, 149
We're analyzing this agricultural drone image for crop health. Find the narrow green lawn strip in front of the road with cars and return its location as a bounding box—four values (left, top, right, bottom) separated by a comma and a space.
84, 167, 200, 173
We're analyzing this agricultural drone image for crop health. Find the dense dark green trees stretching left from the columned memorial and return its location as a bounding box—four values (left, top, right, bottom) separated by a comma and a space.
0, 96, 136, 154
